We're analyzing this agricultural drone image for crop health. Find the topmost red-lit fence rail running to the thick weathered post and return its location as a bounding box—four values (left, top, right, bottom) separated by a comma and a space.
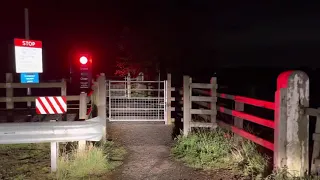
217, 93, 274, 110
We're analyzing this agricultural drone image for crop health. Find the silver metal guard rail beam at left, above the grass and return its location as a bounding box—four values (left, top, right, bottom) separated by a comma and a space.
0, 117, 103, 144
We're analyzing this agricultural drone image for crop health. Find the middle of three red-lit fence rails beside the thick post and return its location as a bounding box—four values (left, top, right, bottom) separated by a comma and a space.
217, 106, 274, 129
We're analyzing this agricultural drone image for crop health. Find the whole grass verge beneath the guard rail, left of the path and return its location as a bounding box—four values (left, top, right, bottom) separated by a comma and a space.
0, 141, 126, 180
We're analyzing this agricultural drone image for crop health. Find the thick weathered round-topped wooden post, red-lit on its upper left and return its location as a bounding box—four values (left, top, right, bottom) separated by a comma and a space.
274, 71, 309, 177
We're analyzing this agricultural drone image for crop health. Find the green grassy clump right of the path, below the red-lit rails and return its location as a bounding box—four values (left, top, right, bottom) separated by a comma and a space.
172, 128, 269, 178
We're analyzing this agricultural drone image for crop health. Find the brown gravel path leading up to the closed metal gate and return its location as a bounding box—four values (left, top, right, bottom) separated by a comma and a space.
109, 123, 233, 180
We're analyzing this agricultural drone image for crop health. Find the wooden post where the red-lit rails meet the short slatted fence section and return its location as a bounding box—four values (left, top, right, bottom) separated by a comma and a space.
210, 77, 217, 129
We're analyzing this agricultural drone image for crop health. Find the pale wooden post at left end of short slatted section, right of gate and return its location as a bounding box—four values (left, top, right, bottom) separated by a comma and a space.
183, 76, 192, 136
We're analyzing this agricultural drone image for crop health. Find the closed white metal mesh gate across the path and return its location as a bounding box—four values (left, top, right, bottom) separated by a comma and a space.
108, 81, 167, 123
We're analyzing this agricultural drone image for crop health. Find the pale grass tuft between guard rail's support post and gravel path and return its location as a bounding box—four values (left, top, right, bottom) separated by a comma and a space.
55, 142, 126, 180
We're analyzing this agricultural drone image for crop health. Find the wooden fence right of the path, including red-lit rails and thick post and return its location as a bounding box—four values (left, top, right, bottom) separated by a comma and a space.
167, 71, 314, 176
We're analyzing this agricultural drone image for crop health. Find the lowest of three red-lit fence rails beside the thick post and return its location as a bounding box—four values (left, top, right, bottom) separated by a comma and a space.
217, 121, 274, 151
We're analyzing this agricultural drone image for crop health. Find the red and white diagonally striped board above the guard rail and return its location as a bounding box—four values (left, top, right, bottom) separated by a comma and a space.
36, 96, 67, 114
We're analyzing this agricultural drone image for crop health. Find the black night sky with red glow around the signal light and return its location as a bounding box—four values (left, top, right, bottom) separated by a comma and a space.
0, 0, 320, 79
